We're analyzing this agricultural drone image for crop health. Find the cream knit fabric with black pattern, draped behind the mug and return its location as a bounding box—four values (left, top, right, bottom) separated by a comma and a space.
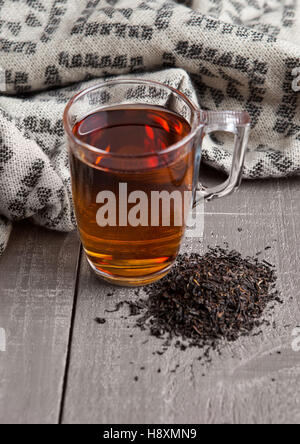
0, 0, 300, 254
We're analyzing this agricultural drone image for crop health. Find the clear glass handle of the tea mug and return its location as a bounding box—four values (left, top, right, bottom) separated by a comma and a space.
195, 111, 251, 204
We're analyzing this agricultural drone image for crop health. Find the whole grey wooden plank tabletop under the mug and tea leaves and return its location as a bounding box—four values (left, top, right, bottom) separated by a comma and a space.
0, 168, 300, 424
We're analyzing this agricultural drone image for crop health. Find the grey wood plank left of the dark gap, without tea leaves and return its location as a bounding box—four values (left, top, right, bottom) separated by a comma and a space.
0, 223, 79, 424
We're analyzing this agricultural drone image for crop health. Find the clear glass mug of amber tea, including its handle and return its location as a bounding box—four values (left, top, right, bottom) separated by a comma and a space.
64, 80, 250, 286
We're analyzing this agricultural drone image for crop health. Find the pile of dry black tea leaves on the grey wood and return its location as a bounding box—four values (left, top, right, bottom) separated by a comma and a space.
106, 247, 282, 350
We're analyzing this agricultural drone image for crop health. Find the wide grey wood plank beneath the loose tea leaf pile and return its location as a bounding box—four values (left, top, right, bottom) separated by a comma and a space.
63, 172, 300, 424
